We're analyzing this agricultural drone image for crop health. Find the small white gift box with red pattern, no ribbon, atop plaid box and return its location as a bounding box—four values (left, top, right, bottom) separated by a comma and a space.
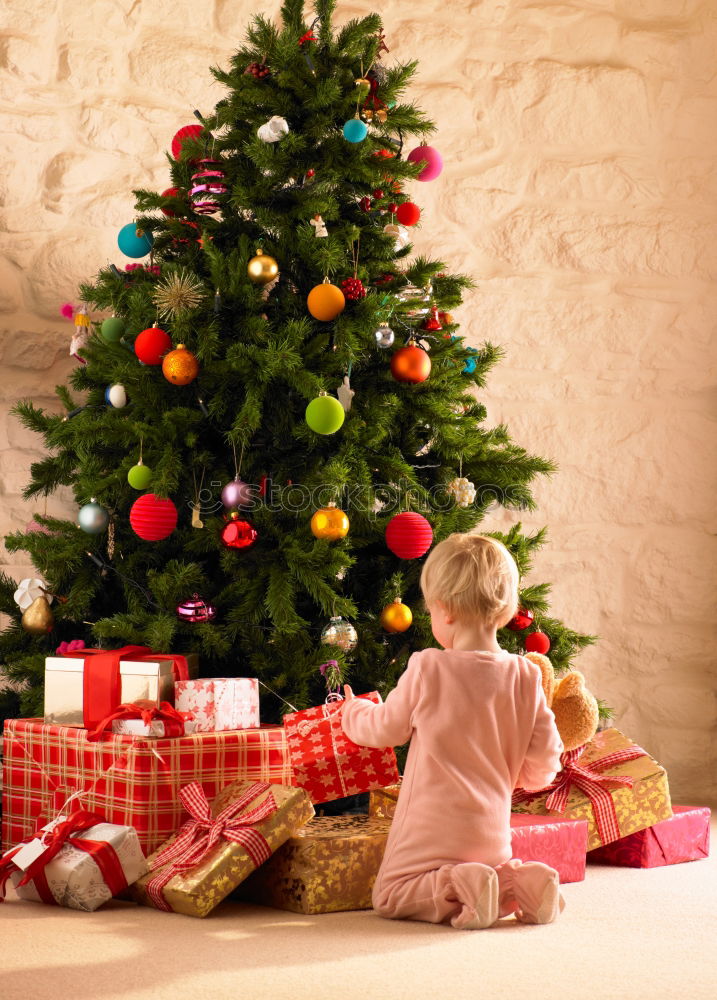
174, 677, 259, 733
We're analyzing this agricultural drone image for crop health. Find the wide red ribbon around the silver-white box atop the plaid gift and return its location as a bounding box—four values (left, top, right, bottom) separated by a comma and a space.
62, 646, 189, 729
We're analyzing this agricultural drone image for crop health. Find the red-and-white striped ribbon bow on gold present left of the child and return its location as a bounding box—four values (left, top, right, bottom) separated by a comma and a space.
147, 781, 276, 911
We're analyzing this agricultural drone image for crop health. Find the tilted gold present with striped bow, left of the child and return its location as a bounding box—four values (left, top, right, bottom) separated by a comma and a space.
130, 781, 314, 917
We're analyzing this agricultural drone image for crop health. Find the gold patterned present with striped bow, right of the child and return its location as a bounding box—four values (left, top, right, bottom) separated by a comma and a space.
512, 729, 672, 851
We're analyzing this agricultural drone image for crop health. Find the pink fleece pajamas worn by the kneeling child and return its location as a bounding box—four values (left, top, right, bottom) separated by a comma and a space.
342, 649, 563, 927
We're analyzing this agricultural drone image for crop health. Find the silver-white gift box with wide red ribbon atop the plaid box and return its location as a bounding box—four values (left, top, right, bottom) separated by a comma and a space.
45, 646, 199, 728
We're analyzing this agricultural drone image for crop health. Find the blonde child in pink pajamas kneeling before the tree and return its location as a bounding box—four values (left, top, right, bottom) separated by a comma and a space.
342, 535, 563, 929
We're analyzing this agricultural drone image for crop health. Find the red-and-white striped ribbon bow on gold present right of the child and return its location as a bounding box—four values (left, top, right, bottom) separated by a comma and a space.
513, 744, 647, 844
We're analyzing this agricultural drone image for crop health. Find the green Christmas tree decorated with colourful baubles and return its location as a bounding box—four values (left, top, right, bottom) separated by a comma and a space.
0, 0, 592, 721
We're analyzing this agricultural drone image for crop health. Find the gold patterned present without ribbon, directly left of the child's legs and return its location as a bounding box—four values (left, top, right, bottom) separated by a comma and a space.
237, 816, 391, 913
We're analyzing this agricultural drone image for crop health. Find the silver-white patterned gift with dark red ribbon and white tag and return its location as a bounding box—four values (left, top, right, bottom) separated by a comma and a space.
5, 814, 147, 911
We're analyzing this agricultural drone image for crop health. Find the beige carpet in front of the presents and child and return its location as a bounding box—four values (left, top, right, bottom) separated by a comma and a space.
0, 821, 717, 1000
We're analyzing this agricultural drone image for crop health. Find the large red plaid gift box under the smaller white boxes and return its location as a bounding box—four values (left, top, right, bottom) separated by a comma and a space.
2, 719, 292, 854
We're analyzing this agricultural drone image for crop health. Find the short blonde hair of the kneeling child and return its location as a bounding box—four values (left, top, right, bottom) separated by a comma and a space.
421, 534, 518, 628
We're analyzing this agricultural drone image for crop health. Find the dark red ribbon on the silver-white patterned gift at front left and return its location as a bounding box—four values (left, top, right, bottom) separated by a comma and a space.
0, 809, 127, 905
